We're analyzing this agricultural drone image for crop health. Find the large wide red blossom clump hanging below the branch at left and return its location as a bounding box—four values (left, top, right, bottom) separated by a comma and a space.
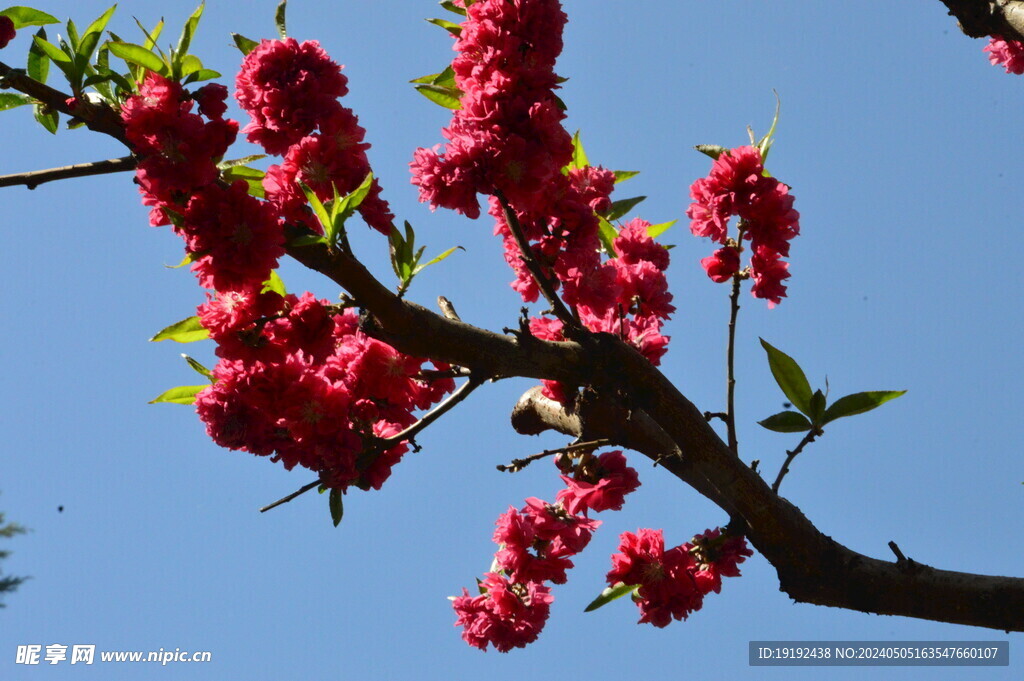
196, 288, 455, 490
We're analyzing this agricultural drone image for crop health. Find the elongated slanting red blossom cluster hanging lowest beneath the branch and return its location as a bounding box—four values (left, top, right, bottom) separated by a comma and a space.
453, 451, 640, 652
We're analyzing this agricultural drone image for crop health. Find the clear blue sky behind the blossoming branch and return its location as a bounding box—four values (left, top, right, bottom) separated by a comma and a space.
0, 0, 1024, 680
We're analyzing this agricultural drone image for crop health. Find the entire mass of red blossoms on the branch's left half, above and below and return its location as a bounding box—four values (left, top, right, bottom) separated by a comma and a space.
122, 40, 455, 490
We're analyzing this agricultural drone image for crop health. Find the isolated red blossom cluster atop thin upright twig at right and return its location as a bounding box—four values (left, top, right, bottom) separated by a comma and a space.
686, 146, 800, 307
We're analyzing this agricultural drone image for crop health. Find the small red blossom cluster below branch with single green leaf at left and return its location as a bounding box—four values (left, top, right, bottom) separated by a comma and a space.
606, 528, 754, 627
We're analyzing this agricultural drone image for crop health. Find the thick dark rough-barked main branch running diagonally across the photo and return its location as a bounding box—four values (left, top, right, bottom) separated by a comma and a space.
0, 45, 1024, 631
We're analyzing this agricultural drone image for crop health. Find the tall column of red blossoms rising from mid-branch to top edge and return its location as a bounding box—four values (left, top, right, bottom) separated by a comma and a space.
411, 0, 675, 400
